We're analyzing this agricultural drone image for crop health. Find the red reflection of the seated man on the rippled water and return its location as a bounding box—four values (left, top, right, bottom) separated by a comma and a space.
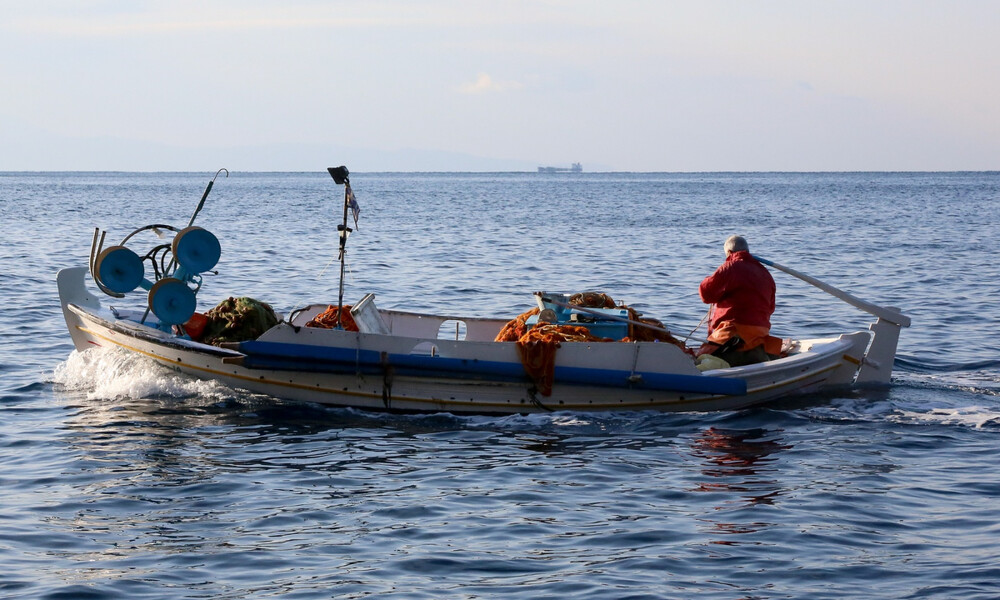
691, 427, 791, 544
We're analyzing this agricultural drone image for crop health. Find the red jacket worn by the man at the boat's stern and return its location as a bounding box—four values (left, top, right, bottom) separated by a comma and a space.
698, 251, 774, 332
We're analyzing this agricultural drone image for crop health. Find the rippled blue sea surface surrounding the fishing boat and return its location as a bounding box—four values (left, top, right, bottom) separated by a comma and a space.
0, 171, 1000, 600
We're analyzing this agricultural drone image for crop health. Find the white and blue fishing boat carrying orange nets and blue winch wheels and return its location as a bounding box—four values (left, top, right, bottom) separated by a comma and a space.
57, 167, 910, 414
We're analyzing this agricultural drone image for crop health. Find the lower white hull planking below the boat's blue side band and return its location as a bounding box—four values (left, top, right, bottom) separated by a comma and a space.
62, 304, 864, 413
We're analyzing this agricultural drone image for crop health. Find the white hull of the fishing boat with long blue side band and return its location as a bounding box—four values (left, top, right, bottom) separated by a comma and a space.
58, 268, 880, 414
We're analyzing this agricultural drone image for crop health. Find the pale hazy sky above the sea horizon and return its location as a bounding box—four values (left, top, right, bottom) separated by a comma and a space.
0, 0, 1000, 172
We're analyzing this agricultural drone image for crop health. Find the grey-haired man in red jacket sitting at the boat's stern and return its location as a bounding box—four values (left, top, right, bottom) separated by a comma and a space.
698, 235, 781, 367
